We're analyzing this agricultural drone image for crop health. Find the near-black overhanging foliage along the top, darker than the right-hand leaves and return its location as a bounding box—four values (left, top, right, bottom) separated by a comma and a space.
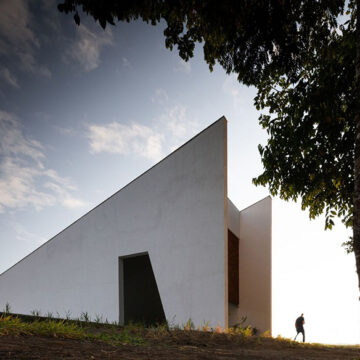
58, 0, 344, 85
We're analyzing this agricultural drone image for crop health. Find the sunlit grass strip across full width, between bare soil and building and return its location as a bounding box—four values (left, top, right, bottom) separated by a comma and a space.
0, 313, 360, 349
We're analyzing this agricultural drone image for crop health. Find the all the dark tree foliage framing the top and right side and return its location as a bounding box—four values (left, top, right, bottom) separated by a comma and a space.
58, 0, 360, 296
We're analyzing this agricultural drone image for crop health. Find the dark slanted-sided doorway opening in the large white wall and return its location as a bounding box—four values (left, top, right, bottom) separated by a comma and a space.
119, 254, 166, 326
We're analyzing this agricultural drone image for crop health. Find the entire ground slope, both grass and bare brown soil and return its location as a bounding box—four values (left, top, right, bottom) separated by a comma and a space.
0, 317, 360, 360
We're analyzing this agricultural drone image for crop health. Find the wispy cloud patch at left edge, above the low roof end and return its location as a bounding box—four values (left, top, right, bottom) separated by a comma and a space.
0, 111, 87, 212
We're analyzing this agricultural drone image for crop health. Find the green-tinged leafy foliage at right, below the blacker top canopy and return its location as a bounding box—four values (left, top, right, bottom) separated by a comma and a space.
254, 22, 356, 233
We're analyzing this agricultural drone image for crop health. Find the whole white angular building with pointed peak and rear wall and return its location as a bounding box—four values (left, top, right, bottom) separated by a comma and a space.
0, 117, 271, 331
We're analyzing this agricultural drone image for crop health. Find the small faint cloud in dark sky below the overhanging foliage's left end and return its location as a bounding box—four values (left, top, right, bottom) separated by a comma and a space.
65, 25, 113, 71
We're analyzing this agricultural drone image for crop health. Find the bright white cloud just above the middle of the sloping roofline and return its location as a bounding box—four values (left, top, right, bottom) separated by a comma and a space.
87, 89, 199, 161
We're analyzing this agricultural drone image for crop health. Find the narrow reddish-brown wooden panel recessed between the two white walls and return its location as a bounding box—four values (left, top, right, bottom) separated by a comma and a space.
228, 230, 239, 305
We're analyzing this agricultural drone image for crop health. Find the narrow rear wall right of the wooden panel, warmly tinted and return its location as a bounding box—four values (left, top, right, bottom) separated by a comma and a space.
237, 196, 271, 332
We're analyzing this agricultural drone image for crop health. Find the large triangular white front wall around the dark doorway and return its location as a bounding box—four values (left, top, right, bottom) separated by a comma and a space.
0, 118, 227, 326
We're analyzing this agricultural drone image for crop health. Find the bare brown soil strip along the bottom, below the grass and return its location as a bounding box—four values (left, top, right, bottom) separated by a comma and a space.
0, 332, 360, 360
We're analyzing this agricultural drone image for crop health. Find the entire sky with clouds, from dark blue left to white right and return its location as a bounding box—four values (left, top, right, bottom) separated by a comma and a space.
0, 0, 360, 343
